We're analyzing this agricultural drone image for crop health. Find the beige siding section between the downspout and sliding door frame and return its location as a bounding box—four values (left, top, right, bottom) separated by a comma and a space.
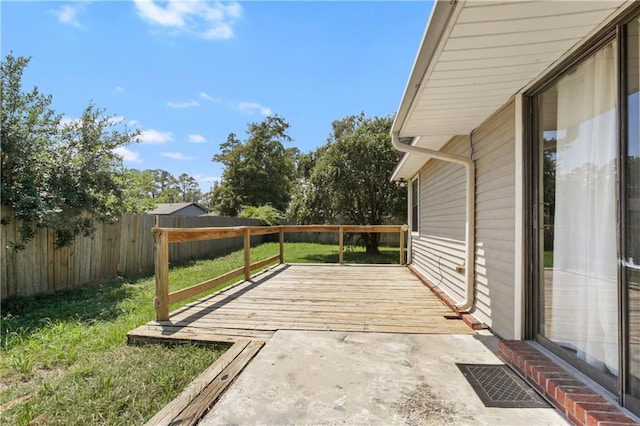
473, 102, 516, 339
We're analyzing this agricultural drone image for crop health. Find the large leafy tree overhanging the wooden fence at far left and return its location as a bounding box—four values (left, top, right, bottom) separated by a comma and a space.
0, 54, 138, 249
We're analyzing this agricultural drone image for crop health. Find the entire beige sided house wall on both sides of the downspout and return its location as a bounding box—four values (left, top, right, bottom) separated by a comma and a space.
411, 101, 516, 339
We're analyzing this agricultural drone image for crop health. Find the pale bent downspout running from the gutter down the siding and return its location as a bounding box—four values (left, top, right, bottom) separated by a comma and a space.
391, 131, 476, 312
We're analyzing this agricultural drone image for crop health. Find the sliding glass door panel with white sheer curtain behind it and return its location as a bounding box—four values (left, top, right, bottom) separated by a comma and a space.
537, 41, 619, 388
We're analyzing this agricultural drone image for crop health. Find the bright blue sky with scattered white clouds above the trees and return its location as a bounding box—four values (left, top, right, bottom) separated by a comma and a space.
0, 0, 432, 191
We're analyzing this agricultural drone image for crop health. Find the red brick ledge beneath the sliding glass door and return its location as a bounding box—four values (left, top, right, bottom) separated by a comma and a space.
498, 340, 638, 426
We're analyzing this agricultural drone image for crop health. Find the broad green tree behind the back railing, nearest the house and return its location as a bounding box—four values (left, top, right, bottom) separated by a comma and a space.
289, 113, 406, 253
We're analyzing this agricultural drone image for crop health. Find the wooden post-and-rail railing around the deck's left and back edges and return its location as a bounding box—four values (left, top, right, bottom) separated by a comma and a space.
153, 225, 408, 321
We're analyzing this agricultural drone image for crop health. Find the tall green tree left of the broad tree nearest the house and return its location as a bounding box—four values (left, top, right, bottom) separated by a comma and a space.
212, 115, 296, 216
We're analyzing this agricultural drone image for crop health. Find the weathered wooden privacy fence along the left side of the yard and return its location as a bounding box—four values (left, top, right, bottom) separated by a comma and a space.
0, 206, 261, 300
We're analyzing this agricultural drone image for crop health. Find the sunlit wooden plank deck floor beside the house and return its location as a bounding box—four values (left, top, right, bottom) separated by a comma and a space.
127, 264, 473, 343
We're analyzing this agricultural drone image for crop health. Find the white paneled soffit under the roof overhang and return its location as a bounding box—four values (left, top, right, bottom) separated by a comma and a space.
393, 0, 625, 178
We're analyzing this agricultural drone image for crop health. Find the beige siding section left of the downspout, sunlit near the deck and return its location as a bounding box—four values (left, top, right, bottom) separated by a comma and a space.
411, 136, 469, 301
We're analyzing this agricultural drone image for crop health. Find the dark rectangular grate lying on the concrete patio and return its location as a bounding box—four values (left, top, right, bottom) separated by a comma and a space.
456, 364, 549, 408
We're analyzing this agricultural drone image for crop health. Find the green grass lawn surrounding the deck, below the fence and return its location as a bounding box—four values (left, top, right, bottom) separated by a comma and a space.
0, 243, 399, 425
